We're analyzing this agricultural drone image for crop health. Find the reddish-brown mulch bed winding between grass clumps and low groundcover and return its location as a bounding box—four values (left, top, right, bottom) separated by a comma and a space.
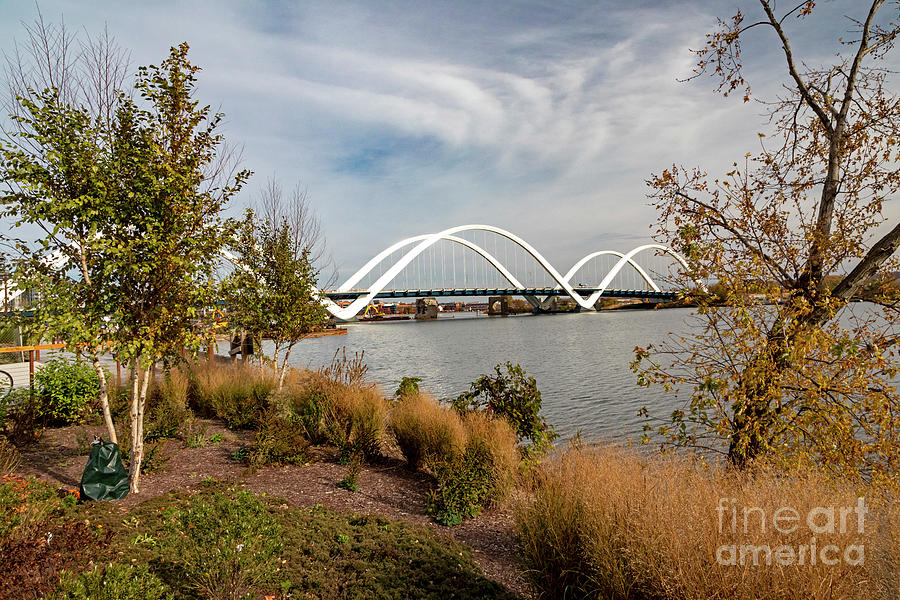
19, 421, 530, 598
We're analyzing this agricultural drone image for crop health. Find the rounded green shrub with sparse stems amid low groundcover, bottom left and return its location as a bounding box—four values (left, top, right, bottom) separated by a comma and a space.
163, 490, 283, 600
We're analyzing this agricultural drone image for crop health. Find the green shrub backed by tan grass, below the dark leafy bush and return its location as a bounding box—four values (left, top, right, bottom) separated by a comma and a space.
425, 412, 518, 526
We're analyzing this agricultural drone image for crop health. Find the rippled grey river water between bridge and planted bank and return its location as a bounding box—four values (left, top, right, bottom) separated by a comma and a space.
270, 309, 690, 440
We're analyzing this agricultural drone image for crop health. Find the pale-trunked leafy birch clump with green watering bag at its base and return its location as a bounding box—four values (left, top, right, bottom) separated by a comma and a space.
2, 36, 249, 492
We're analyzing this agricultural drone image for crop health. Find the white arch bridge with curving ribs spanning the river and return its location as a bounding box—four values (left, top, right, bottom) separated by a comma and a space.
312, 225, 703, 320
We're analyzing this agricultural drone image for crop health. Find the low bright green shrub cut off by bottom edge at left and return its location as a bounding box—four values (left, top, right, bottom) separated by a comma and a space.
51, 563, 175, 600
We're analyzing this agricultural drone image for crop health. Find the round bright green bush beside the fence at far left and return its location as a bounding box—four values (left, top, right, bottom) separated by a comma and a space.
34, 358, 100, 425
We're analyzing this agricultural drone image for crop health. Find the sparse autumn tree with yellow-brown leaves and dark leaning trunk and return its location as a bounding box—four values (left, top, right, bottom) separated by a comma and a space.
634, 0, 900, 483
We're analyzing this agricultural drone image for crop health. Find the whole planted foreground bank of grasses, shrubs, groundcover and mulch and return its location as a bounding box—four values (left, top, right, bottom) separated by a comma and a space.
0, 355, 900, 600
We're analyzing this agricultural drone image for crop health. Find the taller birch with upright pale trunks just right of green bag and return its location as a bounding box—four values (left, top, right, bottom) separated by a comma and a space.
109, 43, 250, 491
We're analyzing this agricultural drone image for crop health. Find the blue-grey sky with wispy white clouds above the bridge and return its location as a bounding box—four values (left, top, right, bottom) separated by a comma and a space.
0, 0, 895, 284
